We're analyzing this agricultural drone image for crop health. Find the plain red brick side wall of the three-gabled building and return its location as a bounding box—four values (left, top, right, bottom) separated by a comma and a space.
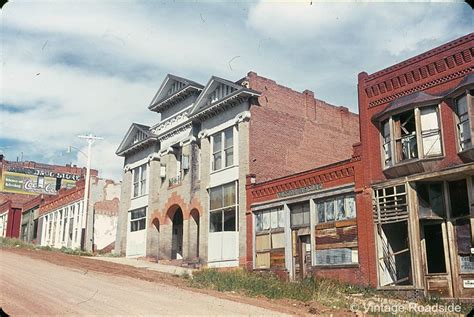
247, 72, 359, 181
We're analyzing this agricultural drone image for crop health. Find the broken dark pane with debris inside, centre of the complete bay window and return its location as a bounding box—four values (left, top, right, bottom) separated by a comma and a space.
393, 110, 418, 162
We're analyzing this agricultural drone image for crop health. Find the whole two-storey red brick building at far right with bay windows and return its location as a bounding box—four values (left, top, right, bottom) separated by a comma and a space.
356, 33, 474, 299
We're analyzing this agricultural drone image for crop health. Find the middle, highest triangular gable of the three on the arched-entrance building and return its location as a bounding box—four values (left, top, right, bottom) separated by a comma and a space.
148, 74, 204, 112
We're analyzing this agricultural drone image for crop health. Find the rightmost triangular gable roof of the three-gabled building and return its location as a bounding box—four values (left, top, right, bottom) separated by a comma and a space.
191, 76, 260, 117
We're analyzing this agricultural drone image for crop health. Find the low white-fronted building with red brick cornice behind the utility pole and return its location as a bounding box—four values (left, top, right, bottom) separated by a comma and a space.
37, 176, 120, 252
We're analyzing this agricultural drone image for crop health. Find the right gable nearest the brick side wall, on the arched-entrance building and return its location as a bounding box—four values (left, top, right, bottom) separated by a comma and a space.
191, 76, 260, 120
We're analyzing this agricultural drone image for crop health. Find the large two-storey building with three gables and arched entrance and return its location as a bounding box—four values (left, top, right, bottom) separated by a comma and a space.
117, 72, 359, 267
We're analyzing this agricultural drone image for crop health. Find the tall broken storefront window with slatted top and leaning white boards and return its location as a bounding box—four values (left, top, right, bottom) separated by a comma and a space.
374, 185, 413, 286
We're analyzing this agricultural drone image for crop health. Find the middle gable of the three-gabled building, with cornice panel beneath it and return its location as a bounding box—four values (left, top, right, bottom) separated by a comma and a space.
148, 74, 204, 120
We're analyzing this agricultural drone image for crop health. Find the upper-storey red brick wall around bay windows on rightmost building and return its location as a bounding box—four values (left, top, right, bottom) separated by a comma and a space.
358, 33, 474, 185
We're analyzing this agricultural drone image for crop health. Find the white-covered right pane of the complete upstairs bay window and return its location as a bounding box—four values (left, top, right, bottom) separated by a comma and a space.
420, 106, 441, 157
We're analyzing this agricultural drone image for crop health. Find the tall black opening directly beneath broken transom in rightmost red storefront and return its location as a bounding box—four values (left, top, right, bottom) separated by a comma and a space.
423, 223, 446, 273
